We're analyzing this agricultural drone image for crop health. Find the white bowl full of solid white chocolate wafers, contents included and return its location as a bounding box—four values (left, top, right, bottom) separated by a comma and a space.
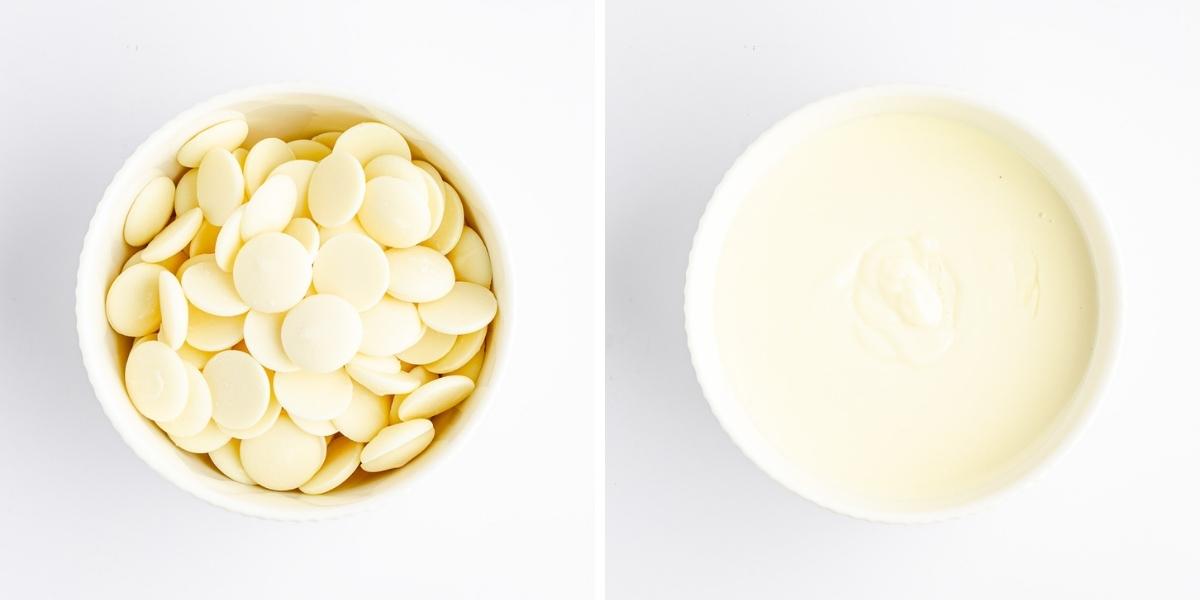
76, 86, 511, 520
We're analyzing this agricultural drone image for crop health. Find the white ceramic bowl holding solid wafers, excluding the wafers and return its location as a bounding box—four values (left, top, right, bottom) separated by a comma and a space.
76, 85, 512, 520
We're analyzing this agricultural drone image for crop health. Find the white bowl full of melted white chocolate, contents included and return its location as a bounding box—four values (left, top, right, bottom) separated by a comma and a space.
686, 88, 1120, 522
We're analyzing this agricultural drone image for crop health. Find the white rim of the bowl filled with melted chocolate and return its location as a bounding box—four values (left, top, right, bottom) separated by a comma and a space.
684, 84, 1123, 523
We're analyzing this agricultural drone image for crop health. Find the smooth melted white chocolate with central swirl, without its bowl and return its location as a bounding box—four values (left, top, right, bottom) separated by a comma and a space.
715, 114, 1097, 508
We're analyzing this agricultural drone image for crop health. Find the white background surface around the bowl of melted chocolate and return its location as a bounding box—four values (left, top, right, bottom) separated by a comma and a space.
606, 0, 1200, 600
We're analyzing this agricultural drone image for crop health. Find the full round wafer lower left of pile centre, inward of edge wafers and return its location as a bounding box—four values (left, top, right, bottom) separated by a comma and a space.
204, 350, 271, 430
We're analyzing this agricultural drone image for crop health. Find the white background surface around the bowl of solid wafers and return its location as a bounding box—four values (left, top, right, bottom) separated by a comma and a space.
0, 1, 599, 599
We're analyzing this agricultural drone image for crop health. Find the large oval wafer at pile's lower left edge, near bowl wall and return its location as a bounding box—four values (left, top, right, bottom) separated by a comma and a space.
125, 340, 187, 421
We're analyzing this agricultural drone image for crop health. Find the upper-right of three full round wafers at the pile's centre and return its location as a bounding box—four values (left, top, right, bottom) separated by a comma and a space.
312, 233, 388, 311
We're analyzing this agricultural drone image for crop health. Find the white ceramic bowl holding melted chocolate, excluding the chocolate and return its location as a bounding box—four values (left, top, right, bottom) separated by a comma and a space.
684, 86, 1121, 522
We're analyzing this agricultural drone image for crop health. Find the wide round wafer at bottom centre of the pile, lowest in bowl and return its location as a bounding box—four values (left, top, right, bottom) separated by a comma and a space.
239, 415, 325, 491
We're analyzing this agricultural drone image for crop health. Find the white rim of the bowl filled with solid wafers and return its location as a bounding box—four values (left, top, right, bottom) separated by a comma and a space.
74, 83, 516, 522
